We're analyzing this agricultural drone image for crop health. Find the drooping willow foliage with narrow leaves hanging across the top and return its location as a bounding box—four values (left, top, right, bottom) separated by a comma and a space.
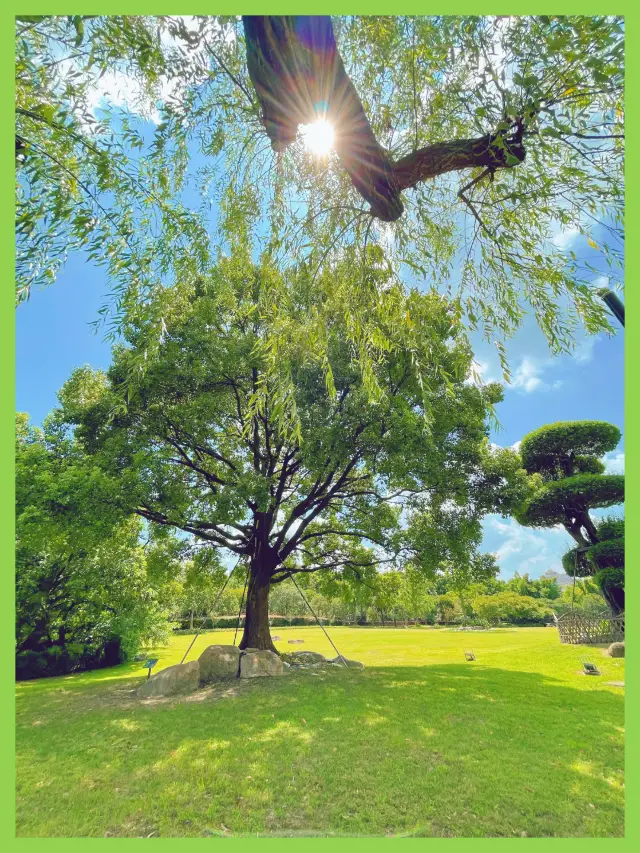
16, 16, 624, 408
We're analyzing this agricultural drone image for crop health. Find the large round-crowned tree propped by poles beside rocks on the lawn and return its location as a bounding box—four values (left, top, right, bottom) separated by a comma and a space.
60, 257, 526, 648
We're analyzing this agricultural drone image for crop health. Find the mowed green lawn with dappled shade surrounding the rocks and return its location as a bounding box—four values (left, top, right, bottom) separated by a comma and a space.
17, 628, 624, 837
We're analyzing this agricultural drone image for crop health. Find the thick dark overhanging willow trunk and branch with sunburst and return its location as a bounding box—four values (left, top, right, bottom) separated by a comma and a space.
243, 15, 525, 222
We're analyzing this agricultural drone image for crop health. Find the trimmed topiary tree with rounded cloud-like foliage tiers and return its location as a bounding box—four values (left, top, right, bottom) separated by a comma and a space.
516, 421, 624, 615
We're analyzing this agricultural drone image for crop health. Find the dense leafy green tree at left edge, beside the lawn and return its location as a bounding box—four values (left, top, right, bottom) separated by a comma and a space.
16, 415, 179, 678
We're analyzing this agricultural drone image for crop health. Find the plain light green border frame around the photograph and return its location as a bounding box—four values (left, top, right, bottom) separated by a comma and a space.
0, 0, 640, 853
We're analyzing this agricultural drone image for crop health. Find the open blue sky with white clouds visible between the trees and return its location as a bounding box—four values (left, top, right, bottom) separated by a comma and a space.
16, 19, 624, 577
